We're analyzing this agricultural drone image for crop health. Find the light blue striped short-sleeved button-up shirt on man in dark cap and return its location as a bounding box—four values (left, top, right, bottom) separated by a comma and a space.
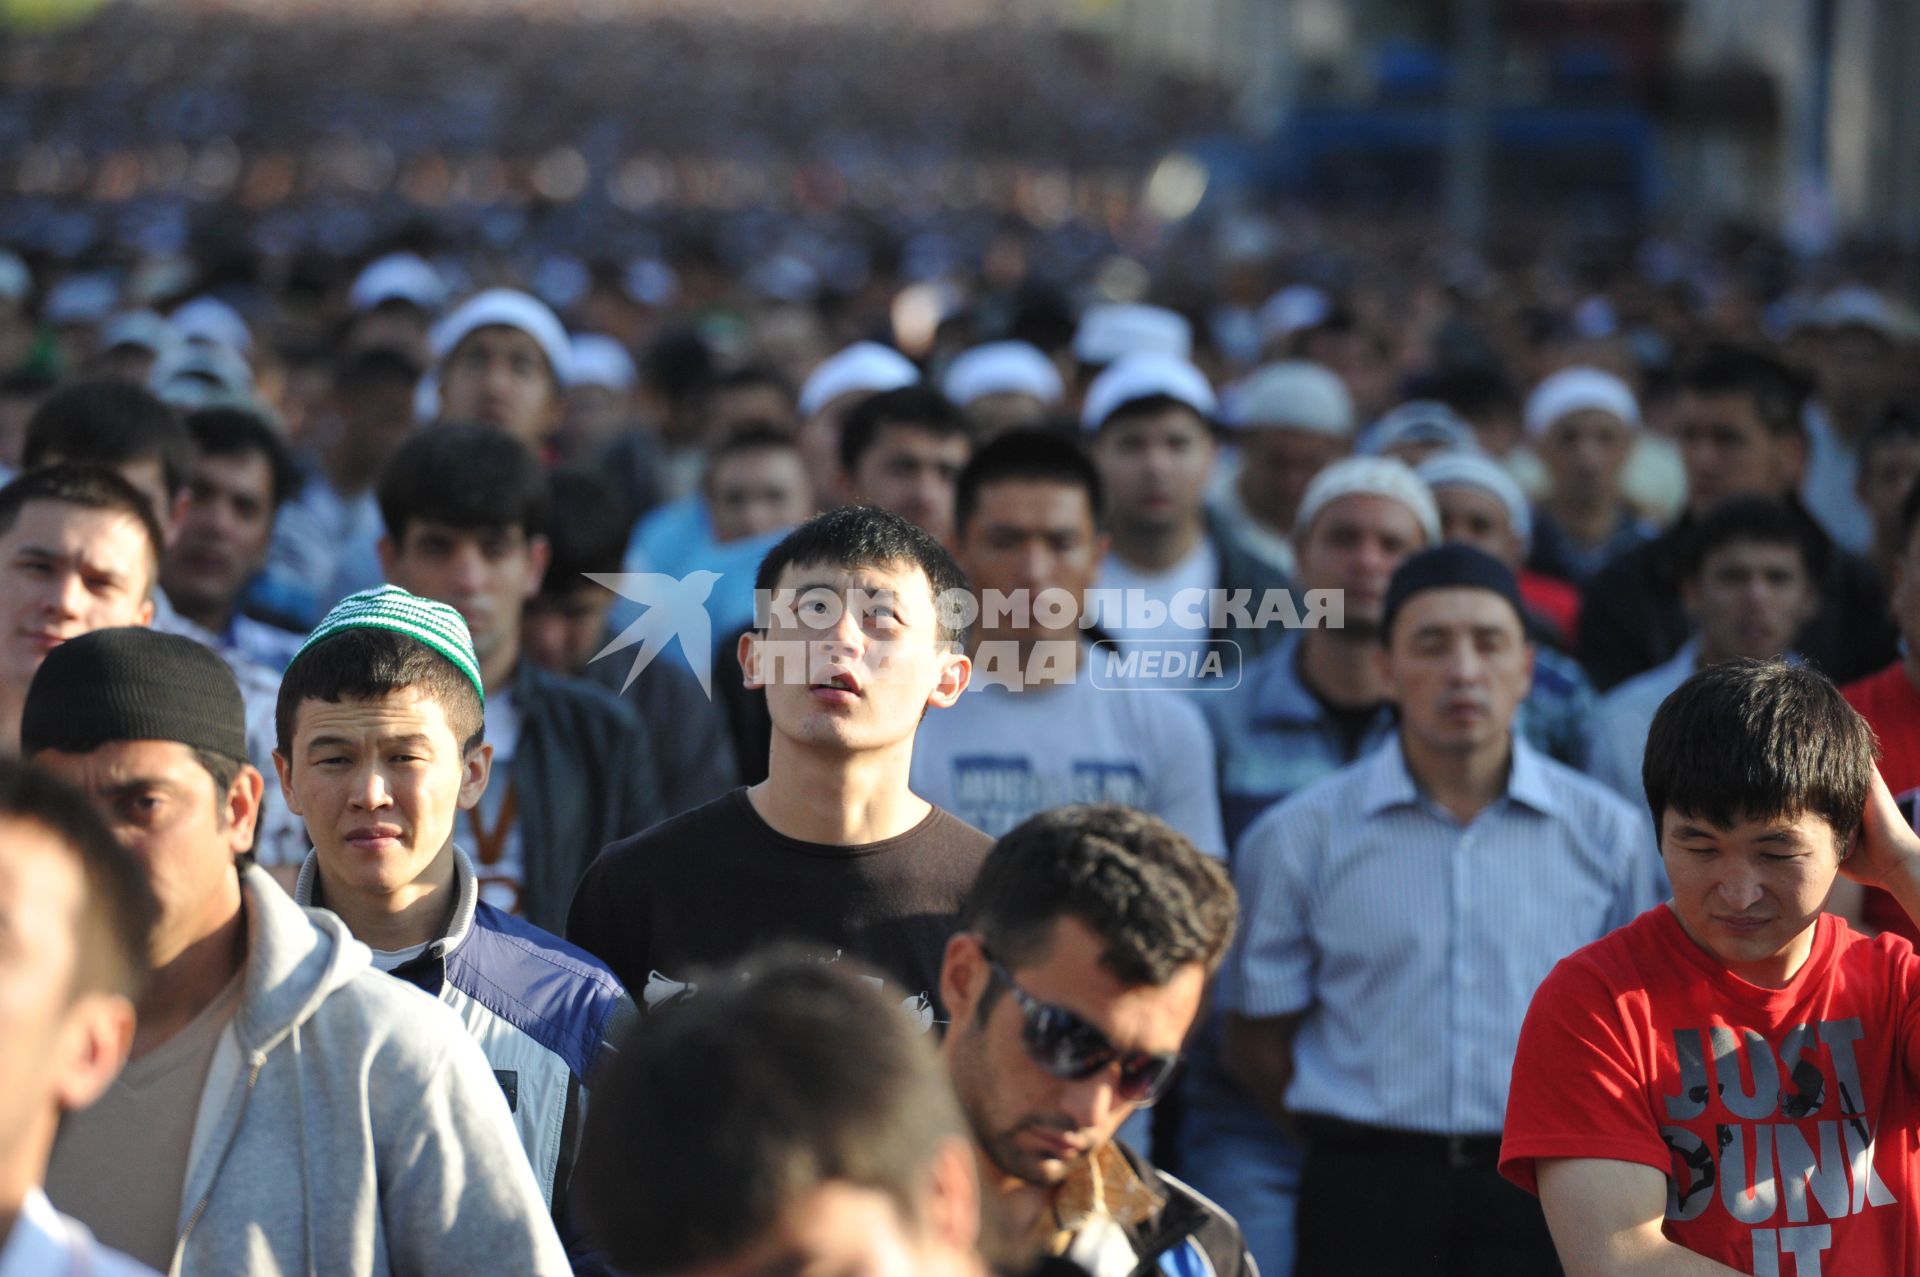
1219, 737, 1655, 1135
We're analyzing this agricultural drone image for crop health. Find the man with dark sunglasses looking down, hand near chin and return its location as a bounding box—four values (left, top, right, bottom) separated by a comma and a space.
941, 807, 1256, 1277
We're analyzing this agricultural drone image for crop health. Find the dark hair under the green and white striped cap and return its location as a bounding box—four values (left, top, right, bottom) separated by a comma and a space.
273, 628, 486, 760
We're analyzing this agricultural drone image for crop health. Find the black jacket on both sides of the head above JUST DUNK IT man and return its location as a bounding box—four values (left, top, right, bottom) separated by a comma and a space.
1578, 501, 1897, 691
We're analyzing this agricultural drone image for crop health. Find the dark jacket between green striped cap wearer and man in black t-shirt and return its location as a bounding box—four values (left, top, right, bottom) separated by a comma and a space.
513, 661, 666, 935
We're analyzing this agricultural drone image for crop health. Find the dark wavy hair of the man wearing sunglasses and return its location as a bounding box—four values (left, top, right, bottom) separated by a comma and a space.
960, 805, 1238, 1016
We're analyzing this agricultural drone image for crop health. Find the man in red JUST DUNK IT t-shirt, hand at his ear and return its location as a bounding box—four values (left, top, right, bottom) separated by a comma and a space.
1500, 661, 1920, 1277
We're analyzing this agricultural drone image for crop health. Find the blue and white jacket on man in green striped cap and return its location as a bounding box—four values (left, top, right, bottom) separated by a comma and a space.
294, 847, 637, 1273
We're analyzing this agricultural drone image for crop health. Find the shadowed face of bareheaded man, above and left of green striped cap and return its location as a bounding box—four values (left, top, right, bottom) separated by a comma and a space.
161, 451, 273, 613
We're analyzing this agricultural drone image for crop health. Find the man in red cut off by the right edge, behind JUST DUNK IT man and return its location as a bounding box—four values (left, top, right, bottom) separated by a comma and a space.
1839, 472, 1920, 945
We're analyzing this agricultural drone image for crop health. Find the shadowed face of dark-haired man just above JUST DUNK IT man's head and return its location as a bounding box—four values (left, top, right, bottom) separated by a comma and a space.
1682, 542, 1820, 661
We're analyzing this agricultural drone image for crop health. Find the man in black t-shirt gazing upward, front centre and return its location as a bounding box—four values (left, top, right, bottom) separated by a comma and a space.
566, 507, 991, 1025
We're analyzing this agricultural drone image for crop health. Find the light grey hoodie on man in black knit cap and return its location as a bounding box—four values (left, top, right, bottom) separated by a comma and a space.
162, 870, 570, 1277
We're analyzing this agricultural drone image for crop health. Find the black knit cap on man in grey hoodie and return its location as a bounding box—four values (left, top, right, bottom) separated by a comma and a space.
19, 626, 248, 762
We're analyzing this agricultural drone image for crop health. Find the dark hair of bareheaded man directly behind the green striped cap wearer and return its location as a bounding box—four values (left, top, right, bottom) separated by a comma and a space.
378, 426, 547, 547
